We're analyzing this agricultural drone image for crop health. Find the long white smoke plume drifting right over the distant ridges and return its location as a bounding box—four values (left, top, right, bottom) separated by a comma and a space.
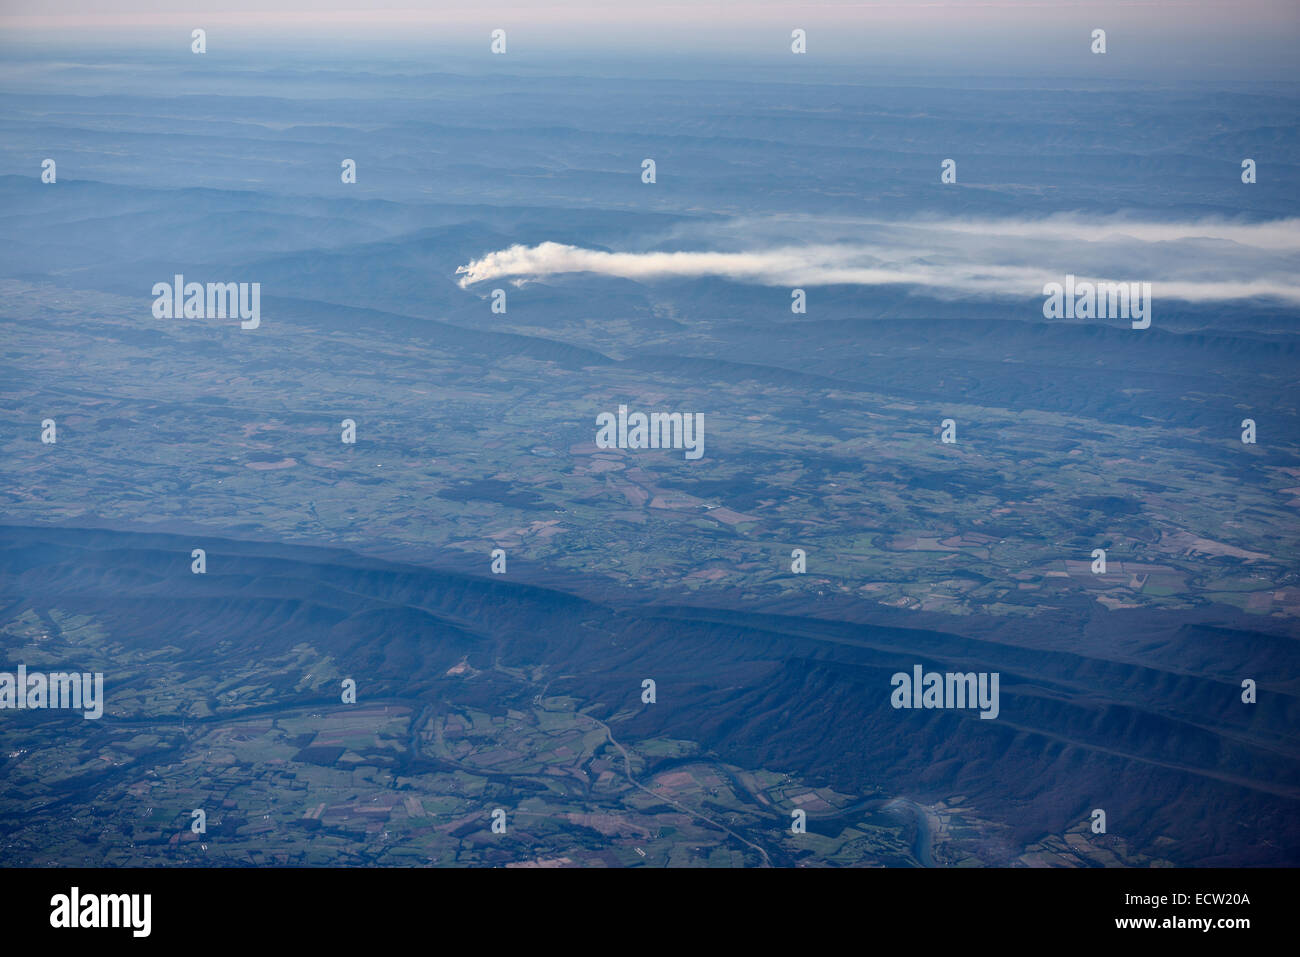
456, 217, 1300, 304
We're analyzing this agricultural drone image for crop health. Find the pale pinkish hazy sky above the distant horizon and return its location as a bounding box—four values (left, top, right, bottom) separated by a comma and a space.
0, 0, 1300, 79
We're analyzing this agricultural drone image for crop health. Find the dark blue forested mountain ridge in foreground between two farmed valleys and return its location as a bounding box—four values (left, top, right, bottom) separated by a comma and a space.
0, 527, 1300, 865
